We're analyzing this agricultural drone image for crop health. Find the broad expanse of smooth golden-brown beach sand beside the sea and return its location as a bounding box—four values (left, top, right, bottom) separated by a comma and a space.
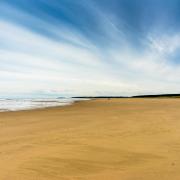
0, 98, 180, 180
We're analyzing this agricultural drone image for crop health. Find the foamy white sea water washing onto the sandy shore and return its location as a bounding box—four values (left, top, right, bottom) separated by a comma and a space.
0, 98, 78, 112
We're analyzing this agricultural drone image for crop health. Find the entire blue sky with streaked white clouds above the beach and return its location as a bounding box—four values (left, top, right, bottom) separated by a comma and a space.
0, 0, 180, 97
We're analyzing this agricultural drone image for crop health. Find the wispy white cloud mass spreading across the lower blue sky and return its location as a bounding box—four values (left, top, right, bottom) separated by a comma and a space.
0, 3, 180, 95
